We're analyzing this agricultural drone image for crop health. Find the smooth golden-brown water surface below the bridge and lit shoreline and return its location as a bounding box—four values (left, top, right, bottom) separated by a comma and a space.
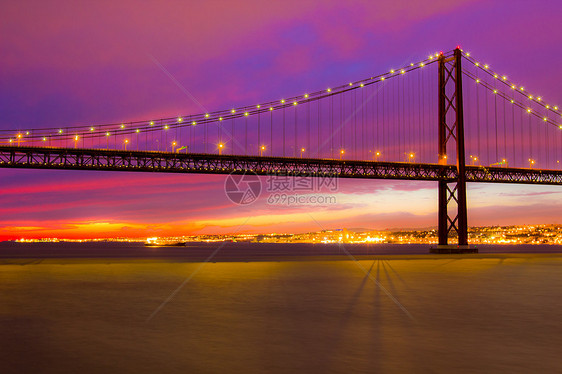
0, 243, 562, 373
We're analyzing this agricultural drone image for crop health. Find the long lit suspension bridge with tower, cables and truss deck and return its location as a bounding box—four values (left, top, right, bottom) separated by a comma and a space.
0, 48, 562, 250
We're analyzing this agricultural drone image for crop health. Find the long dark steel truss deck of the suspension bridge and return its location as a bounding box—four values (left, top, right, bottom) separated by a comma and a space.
0, 146, 562, 185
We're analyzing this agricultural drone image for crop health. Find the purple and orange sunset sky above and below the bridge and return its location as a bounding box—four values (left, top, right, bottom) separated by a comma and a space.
0, 0, 562, 238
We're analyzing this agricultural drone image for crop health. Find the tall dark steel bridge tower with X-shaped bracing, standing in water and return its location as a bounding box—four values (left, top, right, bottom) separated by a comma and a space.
430, 48, 478, 253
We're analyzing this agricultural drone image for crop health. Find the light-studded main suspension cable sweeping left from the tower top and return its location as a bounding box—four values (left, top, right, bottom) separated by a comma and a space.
0, 52, 446, 143
